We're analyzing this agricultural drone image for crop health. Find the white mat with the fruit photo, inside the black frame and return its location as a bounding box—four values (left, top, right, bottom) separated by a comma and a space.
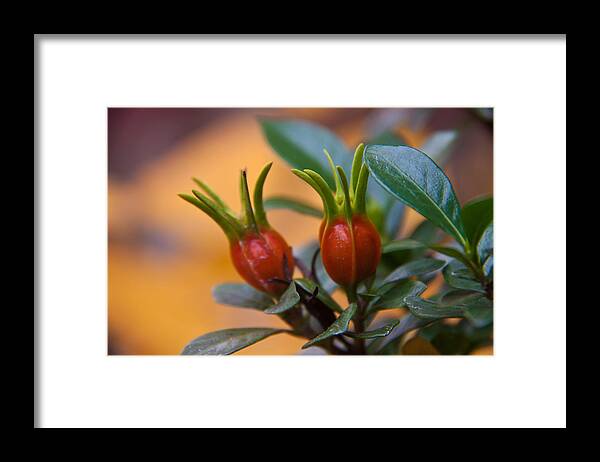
34, 35, 566, 428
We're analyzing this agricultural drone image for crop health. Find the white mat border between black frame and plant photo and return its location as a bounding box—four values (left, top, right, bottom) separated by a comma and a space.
37, 37, 566, 427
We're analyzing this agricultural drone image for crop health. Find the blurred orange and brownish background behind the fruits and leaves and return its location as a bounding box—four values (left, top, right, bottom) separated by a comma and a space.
108, 108, 493, 355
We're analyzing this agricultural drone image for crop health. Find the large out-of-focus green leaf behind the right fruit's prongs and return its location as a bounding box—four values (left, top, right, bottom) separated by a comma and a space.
259, 119, 352, 188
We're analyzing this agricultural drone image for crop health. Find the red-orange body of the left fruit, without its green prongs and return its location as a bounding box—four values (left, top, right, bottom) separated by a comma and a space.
230, 228, 294, 296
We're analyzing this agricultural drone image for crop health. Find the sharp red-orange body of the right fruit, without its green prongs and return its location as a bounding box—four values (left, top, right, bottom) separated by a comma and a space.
320, 215, 381, 287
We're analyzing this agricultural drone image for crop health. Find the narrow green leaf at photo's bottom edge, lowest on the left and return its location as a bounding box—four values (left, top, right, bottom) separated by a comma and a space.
181, 327, 289, 355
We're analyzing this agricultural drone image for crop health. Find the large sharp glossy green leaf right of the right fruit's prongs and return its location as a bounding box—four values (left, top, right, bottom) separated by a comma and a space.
364, 145, 468, 251
